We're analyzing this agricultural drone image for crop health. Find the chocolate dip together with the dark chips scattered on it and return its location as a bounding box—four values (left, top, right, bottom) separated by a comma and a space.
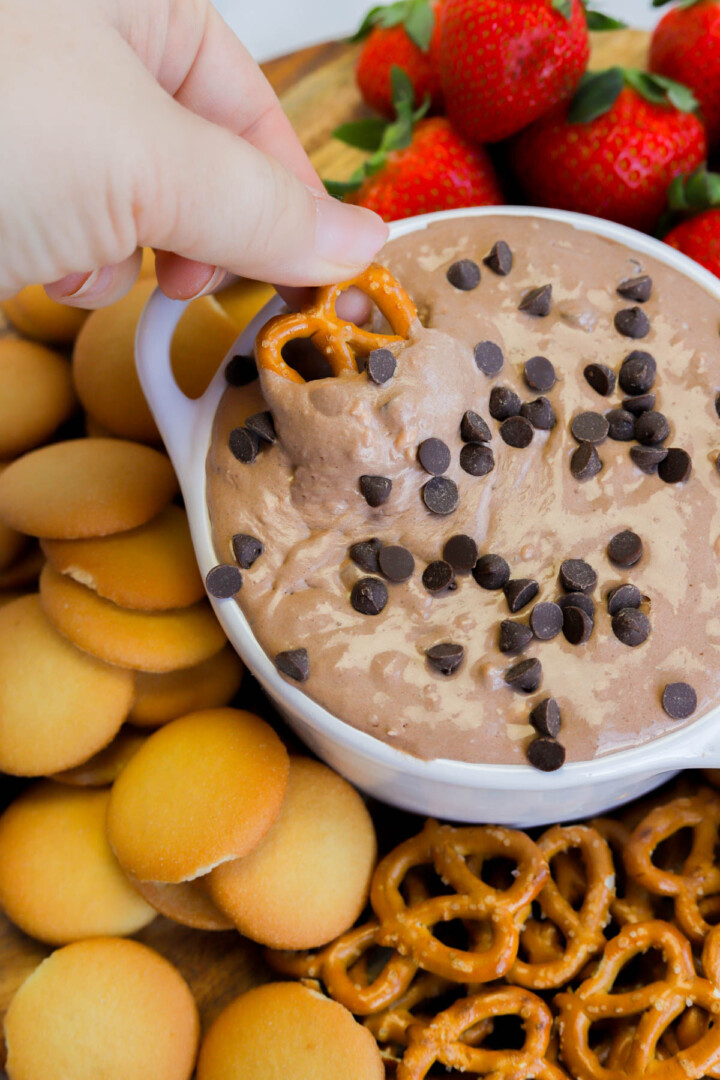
207, 216, 720, 770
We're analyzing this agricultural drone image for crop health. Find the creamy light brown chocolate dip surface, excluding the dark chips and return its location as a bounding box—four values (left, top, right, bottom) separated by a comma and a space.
207, 217, 720, 762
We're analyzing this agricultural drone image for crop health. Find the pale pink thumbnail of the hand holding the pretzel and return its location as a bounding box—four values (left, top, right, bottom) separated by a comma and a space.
313, 192, 390, 267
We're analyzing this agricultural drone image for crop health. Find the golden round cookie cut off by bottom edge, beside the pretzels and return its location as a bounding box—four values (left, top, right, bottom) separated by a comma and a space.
194, 983, 385, 1080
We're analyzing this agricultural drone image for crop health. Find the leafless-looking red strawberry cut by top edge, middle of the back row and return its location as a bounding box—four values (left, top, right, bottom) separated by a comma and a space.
439, 0, 589, 143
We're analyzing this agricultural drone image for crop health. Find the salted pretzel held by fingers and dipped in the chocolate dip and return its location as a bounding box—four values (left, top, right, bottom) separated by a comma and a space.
255, 264, 418, 382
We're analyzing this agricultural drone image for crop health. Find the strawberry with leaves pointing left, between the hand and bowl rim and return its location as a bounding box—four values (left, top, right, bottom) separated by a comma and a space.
326, 68, 504, 221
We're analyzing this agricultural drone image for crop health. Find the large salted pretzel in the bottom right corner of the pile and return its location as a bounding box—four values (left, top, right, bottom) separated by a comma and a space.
555, 919, 720, 1080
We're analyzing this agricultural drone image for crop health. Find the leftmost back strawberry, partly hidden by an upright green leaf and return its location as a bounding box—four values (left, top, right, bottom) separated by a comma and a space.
352, 0, 443, 118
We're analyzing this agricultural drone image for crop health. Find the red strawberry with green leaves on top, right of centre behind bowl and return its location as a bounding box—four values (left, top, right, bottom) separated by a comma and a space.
512, 68, 706, 231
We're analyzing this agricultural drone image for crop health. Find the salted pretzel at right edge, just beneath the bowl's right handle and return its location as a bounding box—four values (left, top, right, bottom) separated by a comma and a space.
625, 791, 720, 945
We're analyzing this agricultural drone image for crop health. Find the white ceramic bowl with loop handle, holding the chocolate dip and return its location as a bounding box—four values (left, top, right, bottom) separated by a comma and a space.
136, 206, 720, 826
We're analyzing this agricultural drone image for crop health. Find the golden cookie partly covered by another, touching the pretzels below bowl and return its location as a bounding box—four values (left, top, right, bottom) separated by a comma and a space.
209, 757, 378, 949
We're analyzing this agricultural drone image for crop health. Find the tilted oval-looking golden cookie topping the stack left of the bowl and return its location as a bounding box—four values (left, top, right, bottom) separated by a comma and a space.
0, 438, 177, 540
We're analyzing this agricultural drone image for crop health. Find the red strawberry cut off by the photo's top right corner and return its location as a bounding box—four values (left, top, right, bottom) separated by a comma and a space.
650, 0, 720, 146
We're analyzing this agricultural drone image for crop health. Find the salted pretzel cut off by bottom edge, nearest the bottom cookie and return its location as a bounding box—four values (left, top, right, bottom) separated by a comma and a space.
397, 986, 567, 1080
